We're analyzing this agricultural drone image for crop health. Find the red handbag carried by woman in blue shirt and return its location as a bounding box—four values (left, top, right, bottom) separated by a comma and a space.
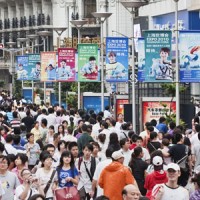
55, 186, 80, 200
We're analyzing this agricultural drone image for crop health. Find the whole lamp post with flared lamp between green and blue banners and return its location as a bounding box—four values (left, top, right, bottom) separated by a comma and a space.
92, 12, 112, 111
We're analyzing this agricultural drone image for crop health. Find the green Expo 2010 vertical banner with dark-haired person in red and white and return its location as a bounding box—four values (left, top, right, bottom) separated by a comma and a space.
78, 44, 99, 82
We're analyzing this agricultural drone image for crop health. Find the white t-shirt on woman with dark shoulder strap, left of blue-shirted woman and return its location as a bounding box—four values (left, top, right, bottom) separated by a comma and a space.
36, 168, 57, 198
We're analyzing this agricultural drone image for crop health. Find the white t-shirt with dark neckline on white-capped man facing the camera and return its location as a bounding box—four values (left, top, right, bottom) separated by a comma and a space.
152, 184, 189, 200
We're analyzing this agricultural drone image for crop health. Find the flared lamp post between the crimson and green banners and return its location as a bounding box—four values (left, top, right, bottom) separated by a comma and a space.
70, 20, 88, 109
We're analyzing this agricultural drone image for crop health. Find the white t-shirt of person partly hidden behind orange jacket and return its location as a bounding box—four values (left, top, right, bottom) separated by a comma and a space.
93, 159, 112, 197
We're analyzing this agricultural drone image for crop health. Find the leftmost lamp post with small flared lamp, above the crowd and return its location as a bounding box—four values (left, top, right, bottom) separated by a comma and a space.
6, 42, 16, 97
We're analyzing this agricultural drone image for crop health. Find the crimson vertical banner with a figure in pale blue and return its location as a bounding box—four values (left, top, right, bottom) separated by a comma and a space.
56, 48, 76, 82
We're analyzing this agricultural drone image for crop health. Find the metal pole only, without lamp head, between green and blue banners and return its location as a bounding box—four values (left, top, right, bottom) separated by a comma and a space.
101, 20, 104, 111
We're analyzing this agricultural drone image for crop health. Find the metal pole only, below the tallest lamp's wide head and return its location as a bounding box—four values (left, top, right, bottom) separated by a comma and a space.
132, 13, 136, 131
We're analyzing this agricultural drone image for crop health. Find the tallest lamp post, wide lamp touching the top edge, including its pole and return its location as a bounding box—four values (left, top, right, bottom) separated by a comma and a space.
120, 0, 147, 131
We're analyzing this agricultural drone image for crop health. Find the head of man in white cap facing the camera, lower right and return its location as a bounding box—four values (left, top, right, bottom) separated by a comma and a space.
167, 163, 181, 183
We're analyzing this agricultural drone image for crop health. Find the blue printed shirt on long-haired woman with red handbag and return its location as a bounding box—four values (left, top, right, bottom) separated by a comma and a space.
57, 167, 78, 188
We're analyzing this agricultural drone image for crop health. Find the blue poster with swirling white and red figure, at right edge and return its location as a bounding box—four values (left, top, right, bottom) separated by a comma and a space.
179, 31, 200, 83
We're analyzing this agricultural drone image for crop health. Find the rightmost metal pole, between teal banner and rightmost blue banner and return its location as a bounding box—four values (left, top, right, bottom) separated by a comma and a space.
175, 0, 180, 125
